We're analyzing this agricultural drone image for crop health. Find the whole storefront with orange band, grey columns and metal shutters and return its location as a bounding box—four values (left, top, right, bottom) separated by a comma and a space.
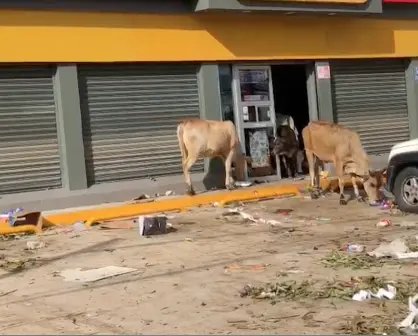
0, 0, 418, 197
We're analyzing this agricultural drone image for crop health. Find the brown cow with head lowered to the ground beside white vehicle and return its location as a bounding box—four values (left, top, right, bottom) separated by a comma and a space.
302, 121, 383, 205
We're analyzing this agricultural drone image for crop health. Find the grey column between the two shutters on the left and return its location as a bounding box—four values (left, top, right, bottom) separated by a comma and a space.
54, 65, 87, 190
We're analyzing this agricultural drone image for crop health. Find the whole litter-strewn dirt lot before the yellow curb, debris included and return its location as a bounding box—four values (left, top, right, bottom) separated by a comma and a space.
4, 191, 418, 335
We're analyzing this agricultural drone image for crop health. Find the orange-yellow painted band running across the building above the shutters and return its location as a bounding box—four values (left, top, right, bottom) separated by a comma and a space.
0, 10, 418, 62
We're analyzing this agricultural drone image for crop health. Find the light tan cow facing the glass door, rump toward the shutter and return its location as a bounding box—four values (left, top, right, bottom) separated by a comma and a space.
177, 119, 249, 195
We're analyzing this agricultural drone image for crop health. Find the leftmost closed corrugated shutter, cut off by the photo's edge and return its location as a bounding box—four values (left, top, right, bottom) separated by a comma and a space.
0, 67, 62, 193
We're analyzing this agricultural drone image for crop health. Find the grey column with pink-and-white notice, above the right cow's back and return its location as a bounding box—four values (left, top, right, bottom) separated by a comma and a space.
315, 61, 335, 122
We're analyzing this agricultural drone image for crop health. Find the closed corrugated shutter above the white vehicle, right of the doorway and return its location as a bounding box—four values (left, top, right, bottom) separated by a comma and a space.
331, 59, 409, 154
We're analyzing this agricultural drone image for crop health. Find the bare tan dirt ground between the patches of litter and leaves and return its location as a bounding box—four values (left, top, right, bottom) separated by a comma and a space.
0, 195, 418, 334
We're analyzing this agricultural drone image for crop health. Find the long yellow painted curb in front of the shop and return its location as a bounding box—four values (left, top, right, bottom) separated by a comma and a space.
0, 178, 362, 234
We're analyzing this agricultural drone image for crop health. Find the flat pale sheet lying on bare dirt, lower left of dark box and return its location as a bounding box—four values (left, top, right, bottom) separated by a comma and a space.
60, 266, 137, 282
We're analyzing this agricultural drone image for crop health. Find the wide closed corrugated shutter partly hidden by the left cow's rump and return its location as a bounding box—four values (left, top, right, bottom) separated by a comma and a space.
79, 64, 203, 184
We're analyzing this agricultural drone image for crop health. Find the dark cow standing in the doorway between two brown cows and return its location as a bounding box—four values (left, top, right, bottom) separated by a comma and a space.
272, 125, 299, 177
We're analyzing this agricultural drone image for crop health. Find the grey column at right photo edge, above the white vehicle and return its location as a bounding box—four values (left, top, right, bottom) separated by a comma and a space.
405, 58, 418, 139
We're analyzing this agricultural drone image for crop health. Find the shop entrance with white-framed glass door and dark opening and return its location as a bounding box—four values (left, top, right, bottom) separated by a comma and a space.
218, 61, 318, 180
